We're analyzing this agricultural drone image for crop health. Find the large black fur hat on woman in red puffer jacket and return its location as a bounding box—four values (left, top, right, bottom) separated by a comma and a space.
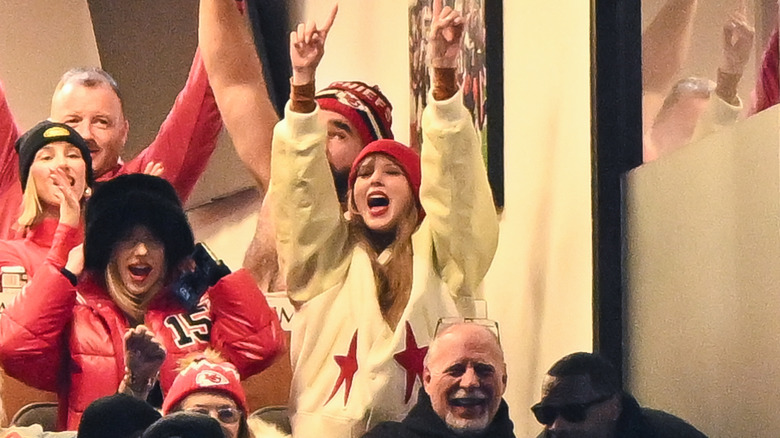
84, 173, 195, 272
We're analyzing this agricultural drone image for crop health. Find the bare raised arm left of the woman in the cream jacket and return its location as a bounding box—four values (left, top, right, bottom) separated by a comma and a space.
198, 0, 279, 193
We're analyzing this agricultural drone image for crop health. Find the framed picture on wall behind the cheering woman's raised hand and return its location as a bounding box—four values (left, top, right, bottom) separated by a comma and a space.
409, 0, 504, 207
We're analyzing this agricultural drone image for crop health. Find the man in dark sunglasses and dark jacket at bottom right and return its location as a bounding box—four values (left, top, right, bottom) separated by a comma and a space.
531, 352, 707, 438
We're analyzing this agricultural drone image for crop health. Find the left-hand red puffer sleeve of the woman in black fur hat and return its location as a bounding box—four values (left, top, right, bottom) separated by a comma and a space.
0, 262, 76, 391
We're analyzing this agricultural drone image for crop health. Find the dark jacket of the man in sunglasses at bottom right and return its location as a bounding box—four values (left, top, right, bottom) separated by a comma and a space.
538, 394, 707, 438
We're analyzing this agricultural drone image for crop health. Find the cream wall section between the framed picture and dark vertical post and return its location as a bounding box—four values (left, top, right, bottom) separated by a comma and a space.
485, 0, 592, 436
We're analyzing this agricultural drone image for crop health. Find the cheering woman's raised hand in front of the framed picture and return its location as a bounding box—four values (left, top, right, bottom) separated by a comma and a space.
429, 0, 464, 68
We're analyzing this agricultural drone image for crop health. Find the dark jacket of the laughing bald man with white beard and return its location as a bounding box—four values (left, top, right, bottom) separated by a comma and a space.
363, 389, 515, 438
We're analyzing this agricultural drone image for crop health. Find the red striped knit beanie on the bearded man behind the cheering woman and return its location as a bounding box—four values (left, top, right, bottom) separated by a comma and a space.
315, 81, 393, 144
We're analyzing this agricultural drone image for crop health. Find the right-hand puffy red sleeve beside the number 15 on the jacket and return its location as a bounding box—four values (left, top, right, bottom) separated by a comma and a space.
208, 269, 285, 379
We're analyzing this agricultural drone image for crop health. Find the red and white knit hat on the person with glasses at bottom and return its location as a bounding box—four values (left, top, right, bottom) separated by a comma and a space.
162, 357, 248, 417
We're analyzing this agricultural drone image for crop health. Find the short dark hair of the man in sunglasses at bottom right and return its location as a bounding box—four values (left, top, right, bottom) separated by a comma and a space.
547, 352, 620, 394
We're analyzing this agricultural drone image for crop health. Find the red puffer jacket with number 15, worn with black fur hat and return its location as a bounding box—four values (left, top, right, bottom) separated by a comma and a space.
0, 260, 284, 430
